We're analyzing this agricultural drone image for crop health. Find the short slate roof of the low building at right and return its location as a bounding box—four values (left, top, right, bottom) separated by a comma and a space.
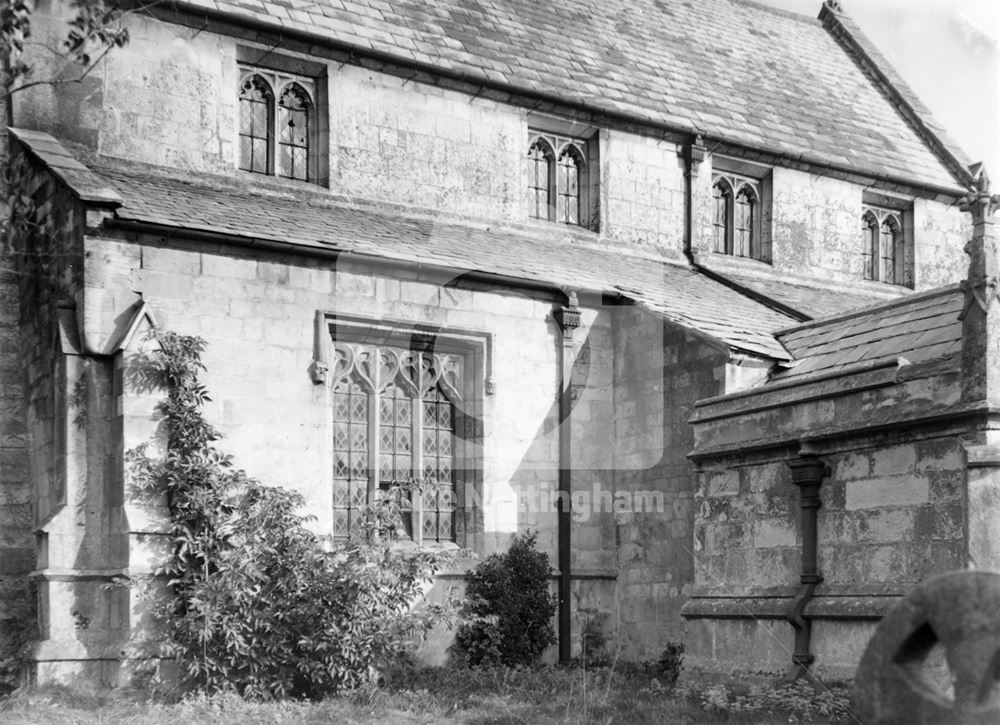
772, 284, 965, 382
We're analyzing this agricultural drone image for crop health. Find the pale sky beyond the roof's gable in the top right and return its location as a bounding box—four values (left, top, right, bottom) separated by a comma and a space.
759, 0, 1000, 181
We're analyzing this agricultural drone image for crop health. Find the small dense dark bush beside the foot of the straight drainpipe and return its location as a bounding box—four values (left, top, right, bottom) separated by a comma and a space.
454, 532, 556, 666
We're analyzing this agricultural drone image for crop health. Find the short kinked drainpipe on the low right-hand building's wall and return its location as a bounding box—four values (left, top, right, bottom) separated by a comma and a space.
787, 453, 830, 680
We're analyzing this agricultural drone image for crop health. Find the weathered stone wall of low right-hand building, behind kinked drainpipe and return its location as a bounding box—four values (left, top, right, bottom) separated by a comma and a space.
684, 359, 983, 675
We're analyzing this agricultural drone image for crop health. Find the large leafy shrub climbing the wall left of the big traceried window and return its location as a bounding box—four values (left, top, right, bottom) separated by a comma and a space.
130, 333, 440, 698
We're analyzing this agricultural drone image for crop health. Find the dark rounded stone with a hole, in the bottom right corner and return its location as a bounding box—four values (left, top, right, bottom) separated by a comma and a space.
854, 571, 1000, 725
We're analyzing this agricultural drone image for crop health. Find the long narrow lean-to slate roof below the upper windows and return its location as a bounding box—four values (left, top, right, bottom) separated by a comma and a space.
93, 167, 795, 360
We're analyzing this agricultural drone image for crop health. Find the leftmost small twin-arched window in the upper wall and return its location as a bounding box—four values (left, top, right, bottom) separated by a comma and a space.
239, 68, 317, 181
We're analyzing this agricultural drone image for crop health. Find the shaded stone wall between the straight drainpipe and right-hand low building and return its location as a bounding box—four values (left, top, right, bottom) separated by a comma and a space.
615, 308, 728, 659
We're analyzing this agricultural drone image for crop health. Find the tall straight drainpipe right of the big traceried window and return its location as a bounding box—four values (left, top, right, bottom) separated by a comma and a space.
553, 291, 580, 662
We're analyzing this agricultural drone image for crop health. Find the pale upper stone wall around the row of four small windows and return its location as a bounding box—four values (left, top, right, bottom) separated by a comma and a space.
16, 5, 966, 276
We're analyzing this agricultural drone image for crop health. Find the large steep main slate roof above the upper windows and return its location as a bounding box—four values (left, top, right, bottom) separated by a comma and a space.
171, 0, 968, 189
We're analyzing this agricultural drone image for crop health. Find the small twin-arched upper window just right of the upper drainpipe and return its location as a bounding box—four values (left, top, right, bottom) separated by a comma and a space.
712, 173, 767, 260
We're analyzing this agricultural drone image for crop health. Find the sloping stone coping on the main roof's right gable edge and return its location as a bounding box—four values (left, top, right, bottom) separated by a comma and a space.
819, 0, 973, 186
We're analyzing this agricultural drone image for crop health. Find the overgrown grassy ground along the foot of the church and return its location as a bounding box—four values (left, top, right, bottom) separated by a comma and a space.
0, 667, 856, 725
